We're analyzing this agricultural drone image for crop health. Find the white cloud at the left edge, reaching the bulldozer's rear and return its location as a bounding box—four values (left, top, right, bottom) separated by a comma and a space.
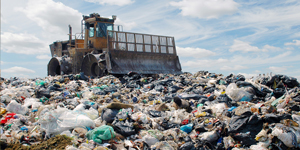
1, 32, 49, 54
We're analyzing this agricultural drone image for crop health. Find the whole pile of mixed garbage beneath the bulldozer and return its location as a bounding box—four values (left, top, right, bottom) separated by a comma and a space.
0, 71, 300, 150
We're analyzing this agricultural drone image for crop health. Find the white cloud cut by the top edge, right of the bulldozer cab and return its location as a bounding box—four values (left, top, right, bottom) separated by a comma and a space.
170, 0, 239, 19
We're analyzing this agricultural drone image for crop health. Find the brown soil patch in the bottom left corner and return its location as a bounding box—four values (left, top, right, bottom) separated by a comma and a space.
5, 135, 72, 150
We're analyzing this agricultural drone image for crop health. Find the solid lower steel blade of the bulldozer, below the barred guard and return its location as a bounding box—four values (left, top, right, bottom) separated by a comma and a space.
106, 50, 182, 74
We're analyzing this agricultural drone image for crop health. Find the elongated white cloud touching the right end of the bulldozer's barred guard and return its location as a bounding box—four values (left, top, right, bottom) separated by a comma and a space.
176, 47, 216, 58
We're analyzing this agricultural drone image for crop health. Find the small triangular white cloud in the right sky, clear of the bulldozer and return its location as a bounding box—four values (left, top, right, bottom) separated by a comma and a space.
229, 40, 261, 52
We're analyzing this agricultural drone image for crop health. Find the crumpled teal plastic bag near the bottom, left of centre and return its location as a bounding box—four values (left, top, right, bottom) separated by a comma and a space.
86, 125, 116, 144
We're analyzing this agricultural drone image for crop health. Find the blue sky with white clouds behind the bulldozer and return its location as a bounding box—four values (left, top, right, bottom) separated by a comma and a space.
1, 0, 300, 81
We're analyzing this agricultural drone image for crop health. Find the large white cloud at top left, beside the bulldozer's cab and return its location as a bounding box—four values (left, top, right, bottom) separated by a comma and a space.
15, 0, 82, 35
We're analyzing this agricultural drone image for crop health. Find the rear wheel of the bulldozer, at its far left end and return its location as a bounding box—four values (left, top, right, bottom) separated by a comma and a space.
48, 56, 72, 76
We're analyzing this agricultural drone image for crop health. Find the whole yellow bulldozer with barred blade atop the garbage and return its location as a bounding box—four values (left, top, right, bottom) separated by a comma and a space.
48, 13, 182, 77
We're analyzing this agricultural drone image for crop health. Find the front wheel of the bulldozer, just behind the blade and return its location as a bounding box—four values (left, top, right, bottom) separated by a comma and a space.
81, 54, 105, 77
